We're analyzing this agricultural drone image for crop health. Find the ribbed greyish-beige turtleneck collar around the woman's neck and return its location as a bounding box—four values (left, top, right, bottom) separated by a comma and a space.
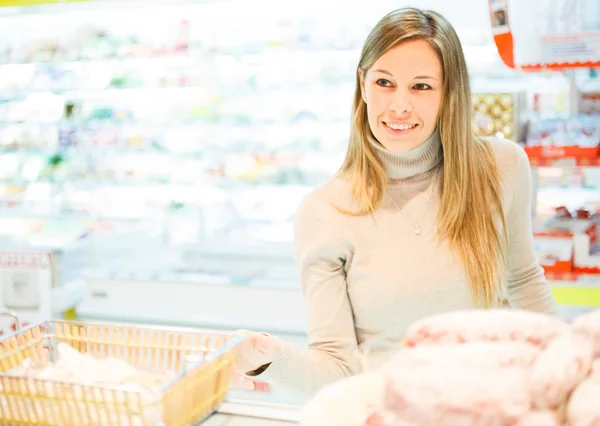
371, 130, 443, 179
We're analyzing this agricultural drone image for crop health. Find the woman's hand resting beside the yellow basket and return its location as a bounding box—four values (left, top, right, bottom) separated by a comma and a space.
231, 330, 281, 390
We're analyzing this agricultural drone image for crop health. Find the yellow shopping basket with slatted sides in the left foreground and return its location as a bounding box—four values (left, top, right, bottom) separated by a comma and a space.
0, 312, 243, 426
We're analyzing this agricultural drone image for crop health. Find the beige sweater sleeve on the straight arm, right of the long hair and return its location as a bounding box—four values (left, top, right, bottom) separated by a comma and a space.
506, 144, 556, 314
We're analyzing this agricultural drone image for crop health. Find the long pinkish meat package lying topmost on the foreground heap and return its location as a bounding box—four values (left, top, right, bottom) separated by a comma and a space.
405, 308, 568, 347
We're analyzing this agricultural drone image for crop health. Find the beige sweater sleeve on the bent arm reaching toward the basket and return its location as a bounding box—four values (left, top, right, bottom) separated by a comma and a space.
254, 190, 360, 396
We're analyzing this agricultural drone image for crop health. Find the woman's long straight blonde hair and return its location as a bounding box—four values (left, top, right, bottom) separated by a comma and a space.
338, 8, 508, 306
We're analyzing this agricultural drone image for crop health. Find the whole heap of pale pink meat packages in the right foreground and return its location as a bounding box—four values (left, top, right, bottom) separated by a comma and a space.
301, 309, 600, 426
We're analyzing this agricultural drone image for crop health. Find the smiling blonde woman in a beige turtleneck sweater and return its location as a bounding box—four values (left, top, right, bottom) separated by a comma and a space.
236, 8, 555, 394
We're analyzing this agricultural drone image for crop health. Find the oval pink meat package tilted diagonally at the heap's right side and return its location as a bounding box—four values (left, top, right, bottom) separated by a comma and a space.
528, 330, 594, 408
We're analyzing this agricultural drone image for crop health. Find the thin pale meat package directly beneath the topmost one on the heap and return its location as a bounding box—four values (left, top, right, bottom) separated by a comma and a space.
383, 342, 541, 370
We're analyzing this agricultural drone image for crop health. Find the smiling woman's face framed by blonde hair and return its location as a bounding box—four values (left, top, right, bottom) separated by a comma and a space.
359, 40, 443, 152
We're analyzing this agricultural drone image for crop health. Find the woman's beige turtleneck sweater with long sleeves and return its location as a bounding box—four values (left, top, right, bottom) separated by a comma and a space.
259, 134, 555, 396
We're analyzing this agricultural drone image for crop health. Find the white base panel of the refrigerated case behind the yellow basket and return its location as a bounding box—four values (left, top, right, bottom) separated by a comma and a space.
77, 277, 307, 334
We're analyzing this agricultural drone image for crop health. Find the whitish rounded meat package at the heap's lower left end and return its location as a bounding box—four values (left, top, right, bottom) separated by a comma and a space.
300, 372, 390, 426
